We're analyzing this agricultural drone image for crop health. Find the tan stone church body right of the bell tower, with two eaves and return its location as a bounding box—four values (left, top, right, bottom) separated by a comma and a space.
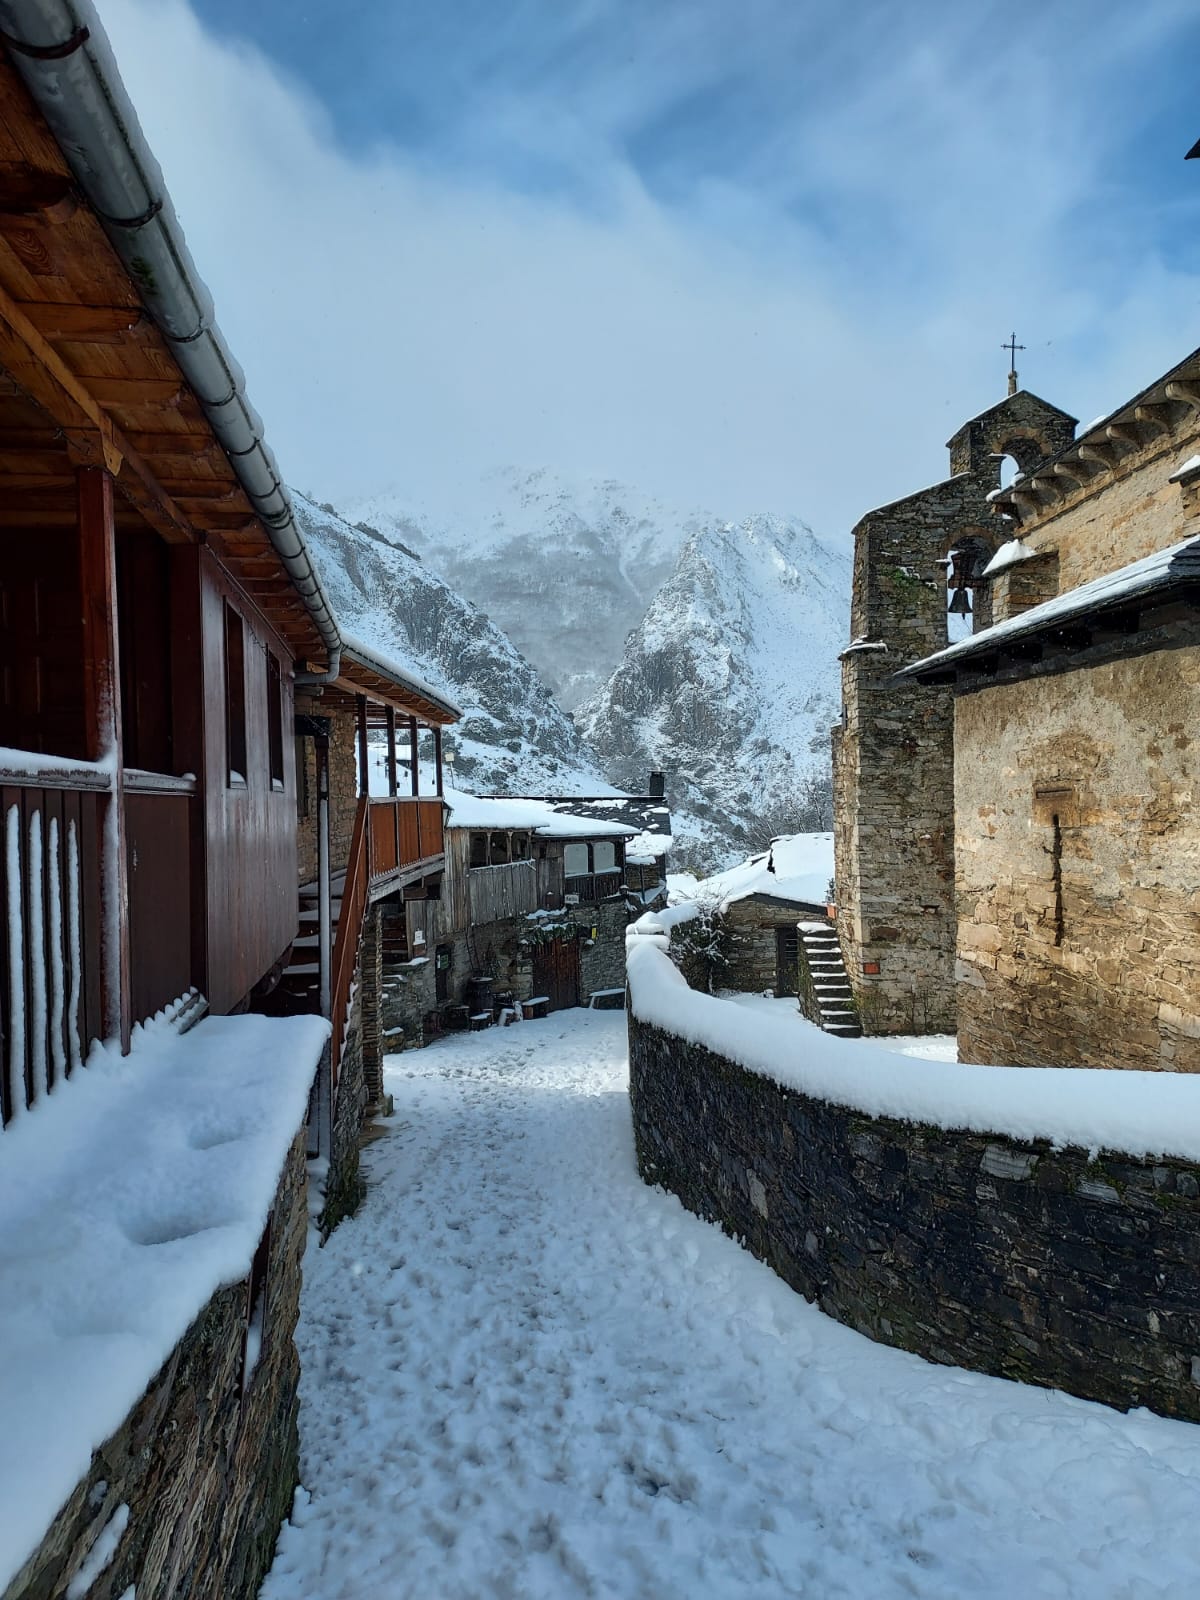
908, 352, 1200, 1072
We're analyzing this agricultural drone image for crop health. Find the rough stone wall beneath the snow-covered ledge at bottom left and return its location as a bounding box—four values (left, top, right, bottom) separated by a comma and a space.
3, 1136, 307, 1600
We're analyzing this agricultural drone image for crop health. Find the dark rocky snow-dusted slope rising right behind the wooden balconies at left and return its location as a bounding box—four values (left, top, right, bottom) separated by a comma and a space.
293, 490, 608, 794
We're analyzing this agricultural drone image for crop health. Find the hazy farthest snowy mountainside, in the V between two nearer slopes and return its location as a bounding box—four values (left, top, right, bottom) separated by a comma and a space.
342, 467, 712, 710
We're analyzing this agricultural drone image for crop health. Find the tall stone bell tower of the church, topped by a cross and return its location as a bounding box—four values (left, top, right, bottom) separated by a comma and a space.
834, 390, 1075, 1034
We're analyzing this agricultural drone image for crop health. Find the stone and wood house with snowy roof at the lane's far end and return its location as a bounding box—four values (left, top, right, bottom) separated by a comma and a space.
382, 781, 670, 1050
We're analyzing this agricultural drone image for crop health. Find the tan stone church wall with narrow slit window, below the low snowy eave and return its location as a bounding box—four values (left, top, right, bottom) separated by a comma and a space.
955, 646, 1200, 1072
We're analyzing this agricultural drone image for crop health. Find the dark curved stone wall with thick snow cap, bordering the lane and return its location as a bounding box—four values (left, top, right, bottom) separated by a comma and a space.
640, 1013, 1200, 1421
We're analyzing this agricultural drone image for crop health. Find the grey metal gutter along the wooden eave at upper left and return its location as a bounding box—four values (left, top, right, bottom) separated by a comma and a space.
0, 0, 342, 683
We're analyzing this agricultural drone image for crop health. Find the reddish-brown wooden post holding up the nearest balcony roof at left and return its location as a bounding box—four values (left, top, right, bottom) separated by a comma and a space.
75, 467, 133, 1051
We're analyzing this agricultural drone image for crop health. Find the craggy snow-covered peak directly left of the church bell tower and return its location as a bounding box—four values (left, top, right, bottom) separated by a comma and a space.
576, 515, 850, 869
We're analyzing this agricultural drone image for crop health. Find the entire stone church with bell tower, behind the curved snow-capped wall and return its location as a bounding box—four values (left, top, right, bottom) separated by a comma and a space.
834, 352, 1200, 1070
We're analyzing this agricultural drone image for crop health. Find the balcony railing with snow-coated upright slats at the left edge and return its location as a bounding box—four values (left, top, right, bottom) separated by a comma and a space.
0, 773, 110, 1123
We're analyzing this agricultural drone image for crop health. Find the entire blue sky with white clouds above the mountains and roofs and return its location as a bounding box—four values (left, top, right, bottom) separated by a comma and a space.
101, 0, 1200, 533
